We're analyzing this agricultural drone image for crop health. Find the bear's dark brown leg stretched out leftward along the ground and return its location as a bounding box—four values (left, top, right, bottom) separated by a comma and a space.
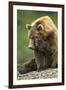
17, 59, 37, 74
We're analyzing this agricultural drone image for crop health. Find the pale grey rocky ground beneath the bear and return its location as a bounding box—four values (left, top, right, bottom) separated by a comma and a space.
17, 68, 58, 80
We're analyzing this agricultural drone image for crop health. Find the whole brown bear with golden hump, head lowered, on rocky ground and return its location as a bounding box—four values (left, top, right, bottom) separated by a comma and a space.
18, 16, 58, 73
